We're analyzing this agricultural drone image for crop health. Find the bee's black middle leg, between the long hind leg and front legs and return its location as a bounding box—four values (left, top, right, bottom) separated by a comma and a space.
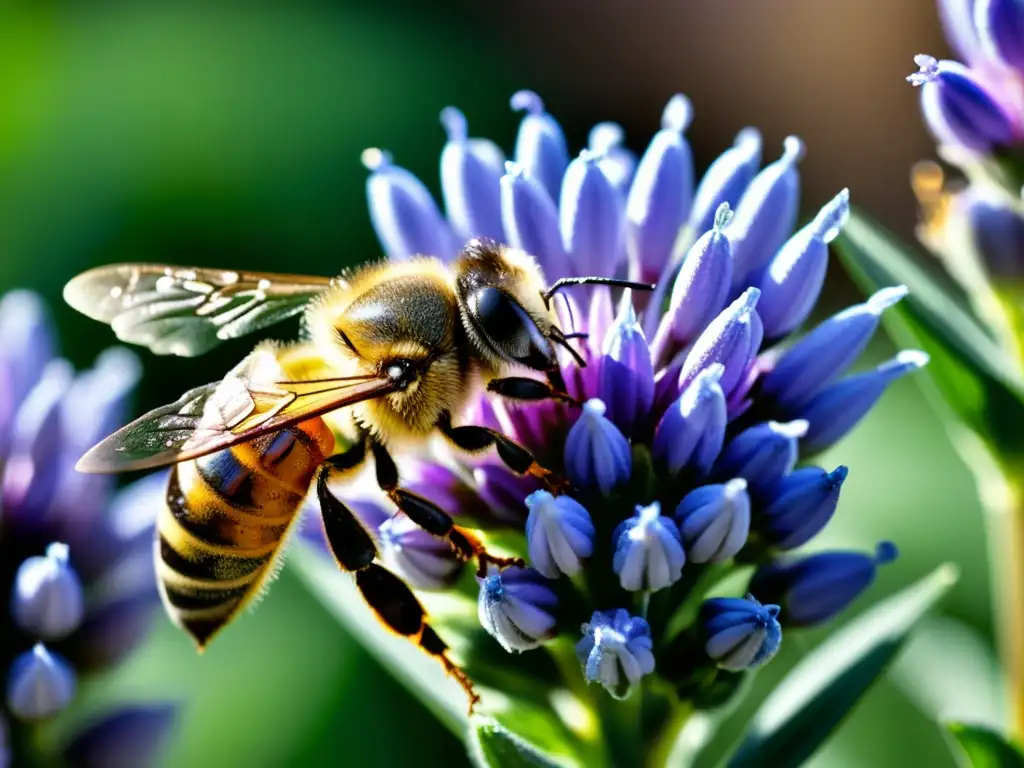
371, 442, 525, 575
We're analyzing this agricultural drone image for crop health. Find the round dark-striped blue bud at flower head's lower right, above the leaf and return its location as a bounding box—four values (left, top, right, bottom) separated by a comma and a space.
700, 595, 782, 672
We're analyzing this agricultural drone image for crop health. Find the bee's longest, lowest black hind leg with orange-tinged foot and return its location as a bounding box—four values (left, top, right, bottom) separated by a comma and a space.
316, 468, 480, 714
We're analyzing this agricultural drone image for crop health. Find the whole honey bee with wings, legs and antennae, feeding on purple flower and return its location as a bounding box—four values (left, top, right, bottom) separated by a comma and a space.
65, 240, 652, 707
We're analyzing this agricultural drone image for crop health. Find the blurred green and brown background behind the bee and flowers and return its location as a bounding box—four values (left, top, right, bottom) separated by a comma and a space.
0, 0, 994, 768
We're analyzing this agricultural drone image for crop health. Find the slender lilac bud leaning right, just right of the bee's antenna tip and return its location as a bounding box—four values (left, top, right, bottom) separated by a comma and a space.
652, 203, 732, 360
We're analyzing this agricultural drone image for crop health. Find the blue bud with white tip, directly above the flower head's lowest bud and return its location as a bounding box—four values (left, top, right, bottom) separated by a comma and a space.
611, 502, 686, 592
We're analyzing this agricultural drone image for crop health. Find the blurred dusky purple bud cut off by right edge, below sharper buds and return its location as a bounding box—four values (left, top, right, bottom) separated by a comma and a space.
967, 190, 1024, 283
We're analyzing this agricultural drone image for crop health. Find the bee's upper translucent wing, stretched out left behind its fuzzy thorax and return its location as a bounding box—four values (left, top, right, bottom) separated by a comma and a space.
65, 264, 332, 357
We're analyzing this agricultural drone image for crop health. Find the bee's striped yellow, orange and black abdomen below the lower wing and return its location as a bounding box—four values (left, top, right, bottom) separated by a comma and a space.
156, 419, 334, 648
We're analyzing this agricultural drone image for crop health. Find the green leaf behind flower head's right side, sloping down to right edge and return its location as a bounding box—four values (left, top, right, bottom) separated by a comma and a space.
837, 211, 1024, 462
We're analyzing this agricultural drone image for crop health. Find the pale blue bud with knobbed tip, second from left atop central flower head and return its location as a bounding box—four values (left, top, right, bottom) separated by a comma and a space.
441, 106, 505, 242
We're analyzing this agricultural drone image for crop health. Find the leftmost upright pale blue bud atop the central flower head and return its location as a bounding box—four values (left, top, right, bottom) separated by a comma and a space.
362, 150, 458, 260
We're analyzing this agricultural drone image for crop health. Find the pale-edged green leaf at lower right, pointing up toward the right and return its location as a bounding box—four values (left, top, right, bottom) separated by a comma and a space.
728, 564, 956, 768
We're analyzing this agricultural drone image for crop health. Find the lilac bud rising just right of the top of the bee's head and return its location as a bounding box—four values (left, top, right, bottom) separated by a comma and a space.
501, 163, 565, 272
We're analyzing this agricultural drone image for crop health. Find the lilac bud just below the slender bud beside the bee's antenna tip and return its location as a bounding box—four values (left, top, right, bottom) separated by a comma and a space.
679, 288, 763, 397
